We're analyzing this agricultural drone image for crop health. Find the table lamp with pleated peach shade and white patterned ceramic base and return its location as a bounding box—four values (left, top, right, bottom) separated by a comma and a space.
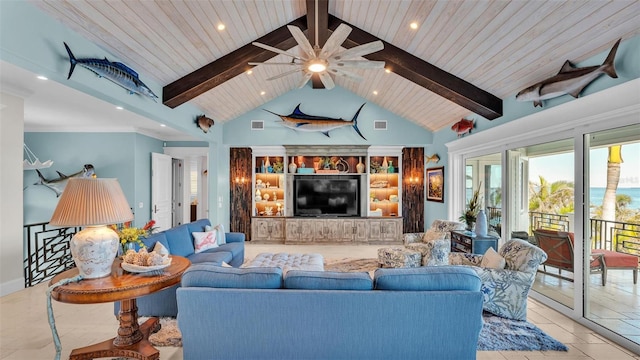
49, 178, 133, 279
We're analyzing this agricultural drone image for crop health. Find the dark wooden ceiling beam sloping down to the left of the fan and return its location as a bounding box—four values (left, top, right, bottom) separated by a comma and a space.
162, 16, 307, 108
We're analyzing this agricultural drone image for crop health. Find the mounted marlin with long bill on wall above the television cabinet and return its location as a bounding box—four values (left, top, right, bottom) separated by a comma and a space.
264, 103, 367, 140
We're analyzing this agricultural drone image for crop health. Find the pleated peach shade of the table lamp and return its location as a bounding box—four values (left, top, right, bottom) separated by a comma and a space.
49, 178, 133, 226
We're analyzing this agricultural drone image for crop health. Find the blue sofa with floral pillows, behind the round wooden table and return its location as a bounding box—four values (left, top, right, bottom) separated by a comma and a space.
114, 219, 245, 317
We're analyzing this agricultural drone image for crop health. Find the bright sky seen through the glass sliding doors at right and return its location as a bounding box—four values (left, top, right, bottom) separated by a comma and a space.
529, 143, 640, 188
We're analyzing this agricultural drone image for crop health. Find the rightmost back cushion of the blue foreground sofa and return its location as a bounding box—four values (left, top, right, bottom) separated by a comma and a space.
373, 265, 481, 291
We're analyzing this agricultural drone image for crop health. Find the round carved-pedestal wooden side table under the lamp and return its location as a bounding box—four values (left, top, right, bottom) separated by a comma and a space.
49, 255, 191, 360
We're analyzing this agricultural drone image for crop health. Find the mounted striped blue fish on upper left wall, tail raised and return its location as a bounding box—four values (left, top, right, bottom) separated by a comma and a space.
64, 43, 158, 101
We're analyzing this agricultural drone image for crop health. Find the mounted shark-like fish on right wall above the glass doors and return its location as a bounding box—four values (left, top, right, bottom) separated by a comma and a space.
516, 39, 622, 107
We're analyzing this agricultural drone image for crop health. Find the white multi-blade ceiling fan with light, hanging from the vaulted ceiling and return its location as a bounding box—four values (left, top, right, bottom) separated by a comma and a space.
249, 2, 384, 89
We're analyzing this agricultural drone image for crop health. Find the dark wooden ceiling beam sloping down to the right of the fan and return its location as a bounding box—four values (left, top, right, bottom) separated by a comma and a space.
329, 15, 502, 120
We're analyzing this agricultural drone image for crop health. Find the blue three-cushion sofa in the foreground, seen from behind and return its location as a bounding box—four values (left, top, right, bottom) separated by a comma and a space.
177, 264, 482, 360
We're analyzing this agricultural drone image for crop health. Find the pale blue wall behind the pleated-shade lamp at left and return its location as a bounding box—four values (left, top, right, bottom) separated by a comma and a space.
23, 132, 163, 226
